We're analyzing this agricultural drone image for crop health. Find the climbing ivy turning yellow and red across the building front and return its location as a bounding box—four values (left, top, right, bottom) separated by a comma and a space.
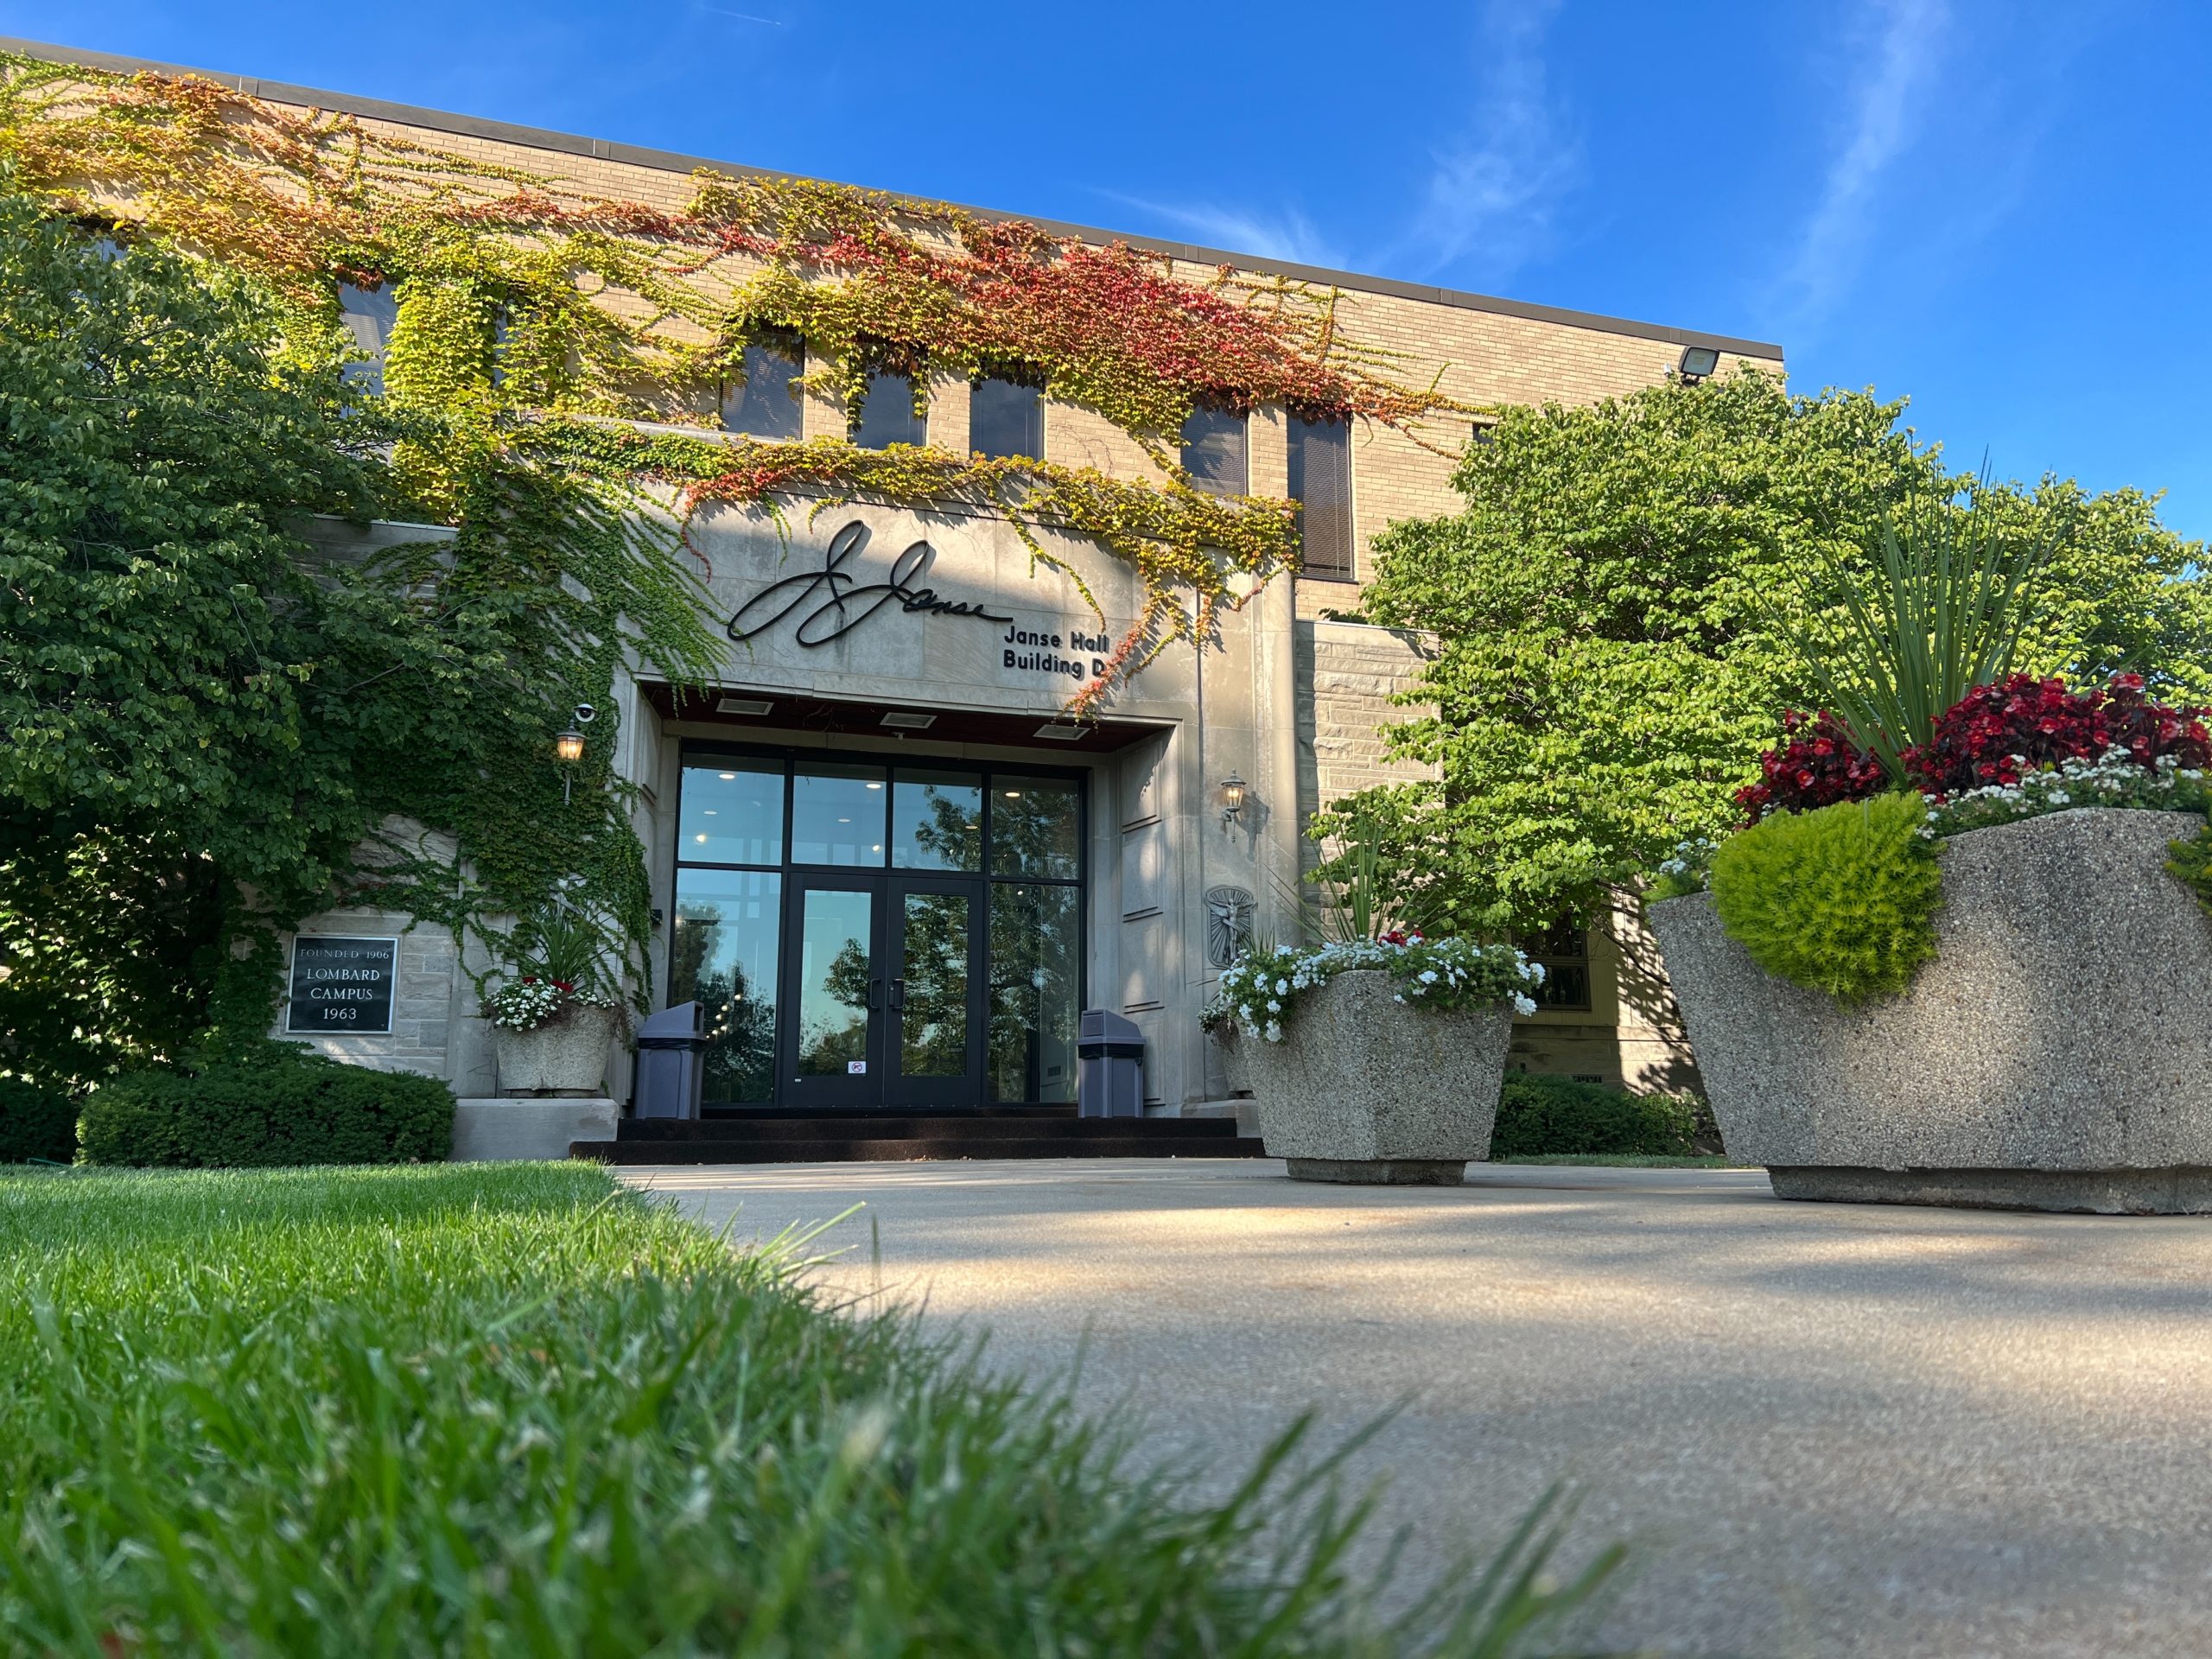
0, 53, 1460, 1065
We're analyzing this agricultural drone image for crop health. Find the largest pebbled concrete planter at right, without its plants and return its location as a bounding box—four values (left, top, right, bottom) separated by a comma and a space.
1650, 807, 2212, 1214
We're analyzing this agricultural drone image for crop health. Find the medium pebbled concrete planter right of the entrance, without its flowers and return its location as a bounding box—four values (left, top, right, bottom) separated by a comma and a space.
1236, 969, 1513, 1185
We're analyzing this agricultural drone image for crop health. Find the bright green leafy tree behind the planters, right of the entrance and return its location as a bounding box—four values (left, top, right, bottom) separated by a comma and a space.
1320, 370, 2212, 933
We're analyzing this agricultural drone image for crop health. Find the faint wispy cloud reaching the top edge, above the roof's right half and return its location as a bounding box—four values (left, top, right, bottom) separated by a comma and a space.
1391, 0, 1581, 283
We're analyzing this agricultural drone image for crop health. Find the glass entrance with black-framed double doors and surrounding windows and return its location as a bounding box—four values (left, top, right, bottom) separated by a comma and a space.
668, 750, 1084, 1110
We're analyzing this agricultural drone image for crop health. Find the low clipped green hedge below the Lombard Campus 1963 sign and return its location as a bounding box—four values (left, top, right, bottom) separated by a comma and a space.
84, 1042, 454, 1168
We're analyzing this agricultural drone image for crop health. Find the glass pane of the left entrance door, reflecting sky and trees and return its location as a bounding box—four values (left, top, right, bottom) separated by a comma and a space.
785, 882, 882, 1106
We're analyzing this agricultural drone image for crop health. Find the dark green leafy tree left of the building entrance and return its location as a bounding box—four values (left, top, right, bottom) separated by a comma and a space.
0, 191, 712, 1082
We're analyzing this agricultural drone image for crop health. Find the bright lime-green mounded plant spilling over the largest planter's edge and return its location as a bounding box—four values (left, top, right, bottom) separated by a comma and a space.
1712, 794, 1942, 1002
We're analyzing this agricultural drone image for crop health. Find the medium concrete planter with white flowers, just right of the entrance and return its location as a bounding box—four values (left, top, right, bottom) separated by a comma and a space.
1205, 931, 1544, 1185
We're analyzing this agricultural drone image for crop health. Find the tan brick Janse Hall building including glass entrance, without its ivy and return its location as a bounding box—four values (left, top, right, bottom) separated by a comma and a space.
0, 42, 1781, 1113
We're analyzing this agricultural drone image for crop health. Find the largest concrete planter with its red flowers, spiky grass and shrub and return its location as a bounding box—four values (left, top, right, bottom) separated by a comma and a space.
1650, 486, 2212, 1212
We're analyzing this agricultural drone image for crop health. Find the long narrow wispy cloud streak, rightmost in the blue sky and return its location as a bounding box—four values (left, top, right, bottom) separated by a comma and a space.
1778, 0, 1951, 329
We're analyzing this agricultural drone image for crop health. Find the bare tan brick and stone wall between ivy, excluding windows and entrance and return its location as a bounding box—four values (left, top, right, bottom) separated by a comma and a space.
48, 32, 1781, 1110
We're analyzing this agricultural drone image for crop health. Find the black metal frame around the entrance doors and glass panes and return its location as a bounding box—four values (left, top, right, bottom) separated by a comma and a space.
661, 736, 1090, 1113
